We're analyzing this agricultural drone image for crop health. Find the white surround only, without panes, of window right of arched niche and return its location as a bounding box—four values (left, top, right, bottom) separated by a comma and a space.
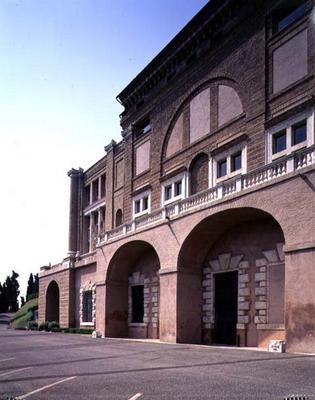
209, 142, 247, 187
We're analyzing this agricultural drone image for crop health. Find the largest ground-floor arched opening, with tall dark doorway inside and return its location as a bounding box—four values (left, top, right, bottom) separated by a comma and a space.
178, 208, 285, 347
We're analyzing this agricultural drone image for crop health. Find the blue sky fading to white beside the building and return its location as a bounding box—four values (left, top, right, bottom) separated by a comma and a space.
0, 0, 207, 294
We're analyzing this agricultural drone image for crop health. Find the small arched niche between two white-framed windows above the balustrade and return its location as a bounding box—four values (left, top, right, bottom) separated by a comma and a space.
189, 153, 209, 195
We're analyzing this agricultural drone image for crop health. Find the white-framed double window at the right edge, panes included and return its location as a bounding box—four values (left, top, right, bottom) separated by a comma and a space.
266, 110, 314, 162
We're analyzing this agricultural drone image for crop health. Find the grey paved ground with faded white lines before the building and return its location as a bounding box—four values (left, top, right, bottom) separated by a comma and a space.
0, 329, 315, 400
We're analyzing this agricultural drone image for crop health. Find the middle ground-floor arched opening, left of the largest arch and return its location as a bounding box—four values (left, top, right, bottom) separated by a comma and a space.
105, 241, 160, 339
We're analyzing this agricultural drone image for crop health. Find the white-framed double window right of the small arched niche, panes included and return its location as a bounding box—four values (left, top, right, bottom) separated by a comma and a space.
210, 143, 246, 187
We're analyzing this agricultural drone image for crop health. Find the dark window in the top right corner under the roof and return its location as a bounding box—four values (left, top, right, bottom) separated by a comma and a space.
273, 0, 306, 33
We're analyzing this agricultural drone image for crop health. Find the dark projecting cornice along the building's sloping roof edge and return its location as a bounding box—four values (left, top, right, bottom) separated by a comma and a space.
117, 0, 256, 111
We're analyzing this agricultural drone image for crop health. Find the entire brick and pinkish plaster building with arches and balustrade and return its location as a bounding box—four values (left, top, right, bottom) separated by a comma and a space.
39, 0, 315, 351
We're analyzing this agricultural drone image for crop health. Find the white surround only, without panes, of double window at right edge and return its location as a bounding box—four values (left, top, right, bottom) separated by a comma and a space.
266, 109, 315, 164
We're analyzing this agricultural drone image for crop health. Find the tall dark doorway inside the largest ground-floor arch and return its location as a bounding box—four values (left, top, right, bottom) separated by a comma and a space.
213, 271, 238, 345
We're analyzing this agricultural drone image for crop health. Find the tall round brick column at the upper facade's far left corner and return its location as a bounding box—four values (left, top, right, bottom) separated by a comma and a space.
68, 168, 83, 255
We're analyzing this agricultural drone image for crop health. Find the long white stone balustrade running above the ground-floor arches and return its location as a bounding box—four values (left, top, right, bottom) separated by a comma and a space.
99, 145, 315, 245
